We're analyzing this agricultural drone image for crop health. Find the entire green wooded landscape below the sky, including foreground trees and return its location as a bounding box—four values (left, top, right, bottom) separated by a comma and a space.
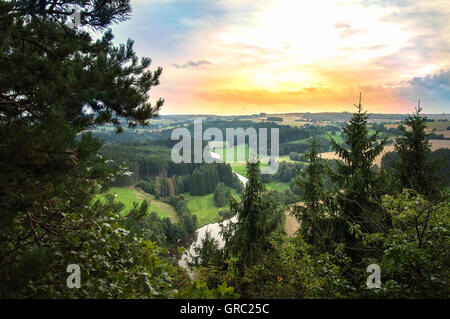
0, 0, 450, 299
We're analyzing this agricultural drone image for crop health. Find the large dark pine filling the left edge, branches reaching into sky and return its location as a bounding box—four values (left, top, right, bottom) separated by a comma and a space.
0, 0, 169, 296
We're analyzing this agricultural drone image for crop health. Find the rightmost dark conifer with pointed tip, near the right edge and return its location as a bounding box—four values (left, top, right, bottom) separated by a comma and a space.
393, 101, 444, 197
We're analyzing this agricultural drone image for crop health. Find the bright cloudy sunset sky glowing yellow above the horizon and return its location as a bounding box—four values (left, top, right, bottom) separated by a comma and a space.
112, 0, 450, 115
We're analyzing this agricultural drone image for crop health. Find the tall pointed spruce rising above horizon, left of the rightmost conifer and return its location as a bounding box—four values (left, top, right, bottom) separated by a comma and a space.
331, 95, 387, 252
